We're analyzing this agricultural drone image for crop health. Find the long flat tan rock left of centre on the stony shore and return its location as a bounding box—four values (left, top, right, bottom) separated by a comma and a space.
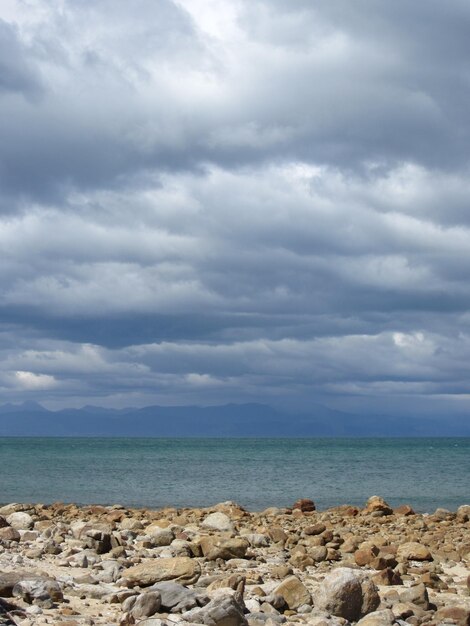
122, 556, 201, 587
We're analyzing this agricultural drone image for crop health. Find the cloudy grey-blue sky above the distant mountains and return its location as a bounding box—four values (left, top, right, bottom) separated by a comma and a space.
0, 0, 470, 418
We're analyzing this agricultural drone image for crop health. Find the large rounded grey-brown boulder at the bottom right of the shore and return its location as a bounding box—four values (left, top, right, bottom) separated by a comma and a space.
314, 567, 380, 621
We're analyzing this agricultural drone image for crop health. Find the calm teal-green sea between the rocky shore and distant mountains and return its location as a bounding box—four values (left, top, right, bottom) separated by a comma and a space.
0, 437, 470, 512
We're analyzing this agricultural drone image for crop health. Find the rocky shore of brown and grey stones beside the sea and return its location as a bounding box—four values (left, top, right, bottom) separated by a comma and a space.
0, 496, 470, 626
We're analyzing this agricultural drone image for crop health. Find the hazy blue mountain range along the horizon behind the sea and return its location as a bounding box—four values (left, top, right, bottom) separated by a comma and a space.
0, 402, 470, 437
